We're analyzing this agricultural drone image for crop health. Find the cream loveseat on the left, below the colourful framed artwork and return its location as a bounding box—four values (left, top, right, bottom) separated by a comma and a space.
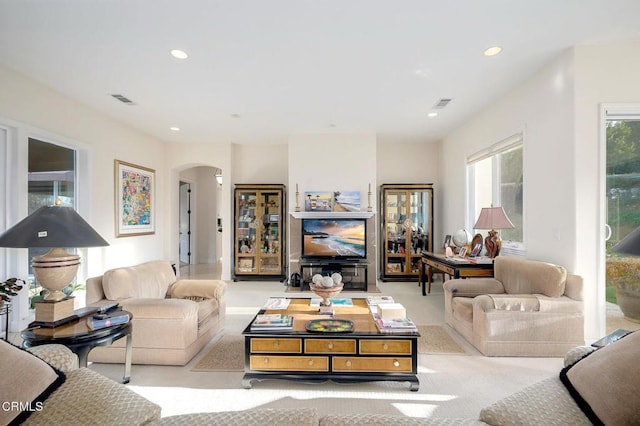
87, 261, 227, 365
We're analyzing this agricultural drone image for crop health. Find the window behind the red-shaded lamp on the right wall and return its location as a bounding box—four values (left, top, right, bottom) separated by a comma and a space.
467, 133, 524, 254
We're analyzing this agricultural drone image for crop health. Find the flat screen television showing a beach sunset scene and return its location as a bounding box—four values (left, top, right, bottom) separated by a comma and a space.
302, 218, 367, 260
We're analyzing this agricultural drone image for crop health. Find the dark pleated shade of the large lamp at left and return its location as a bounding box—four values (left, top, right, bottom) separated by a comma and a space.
0, 206, 109, 248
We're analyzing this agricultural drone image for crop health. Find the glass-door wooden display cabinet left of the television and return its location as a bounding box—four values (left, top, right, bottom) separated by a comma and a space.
233, 184, 287, 281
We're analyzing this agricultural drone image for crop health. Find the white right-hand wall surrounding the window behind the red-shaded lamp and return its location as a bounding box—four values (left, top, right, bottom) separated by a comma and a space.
442, 44, 640, 339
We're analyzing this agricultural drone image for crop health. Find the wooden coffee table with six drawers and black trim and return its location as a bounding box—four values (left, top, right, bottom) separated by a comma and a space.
242, 298, 420, 391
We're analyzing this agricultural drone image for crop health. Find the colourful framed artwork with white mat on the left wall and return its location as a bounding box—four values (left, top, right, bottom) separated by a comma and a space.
115, 160, 156, 237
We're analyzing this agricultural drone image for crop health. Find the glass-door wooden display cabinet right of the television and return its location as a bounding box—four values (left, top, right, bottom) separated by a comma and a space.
380, 184, 433, 281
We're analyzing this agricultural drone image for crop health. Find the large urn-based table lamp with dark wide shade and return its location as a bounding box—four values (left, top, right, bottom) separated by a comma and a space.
0, 200, 109, 325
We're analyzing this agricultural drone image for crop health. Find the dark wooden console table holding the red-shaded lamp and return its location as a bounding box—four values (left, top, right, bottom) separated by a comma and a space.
418, 252, 493, 296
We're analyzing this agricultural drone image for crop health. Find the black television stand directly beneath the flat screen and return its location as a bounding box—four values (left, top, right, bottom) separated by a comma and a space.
300, 259, 369, 291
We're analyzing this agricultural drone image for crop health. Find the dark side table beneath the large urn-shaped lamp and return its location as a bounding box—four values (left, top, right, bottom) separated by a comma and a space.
20, 311, 132, 383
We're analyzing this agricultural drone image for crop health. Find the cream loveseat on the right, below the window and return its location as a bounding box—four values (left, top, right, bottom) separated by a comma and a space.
443, 256, 584, 356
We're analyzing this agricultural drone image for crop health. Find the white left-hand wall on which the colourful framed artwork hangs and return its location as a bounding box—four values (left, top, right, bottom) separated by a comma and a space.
0, 67, 168, 327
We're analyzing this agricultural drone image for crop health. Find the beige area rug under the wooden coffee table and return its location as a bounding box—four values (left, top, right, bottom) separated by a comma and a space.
191, 325, 465, 371
